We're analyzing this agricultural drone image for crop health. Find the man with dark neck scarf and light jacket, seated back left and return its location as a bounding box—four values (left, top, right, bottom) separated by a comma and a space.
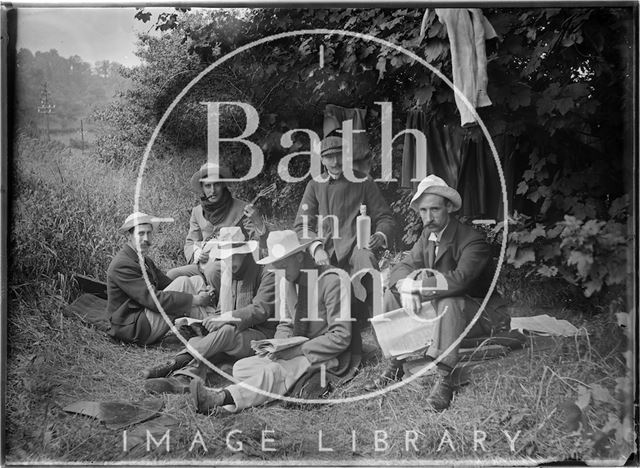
167, 163, 268, 281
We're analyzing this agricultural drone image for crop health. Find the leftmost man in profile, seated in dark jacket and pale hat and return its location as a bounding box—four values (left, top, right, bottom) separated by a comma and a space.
107, 212, 213, 345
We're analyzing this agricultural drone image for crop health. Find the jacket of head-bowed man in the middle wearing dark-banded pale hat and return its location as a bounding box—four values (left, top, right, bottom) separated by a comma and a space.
212, 259, 277, 338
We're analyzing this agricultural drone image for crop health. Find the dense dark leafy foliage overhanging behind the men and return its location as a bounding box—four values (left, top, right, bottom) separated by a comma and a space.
91, 7, 633, 304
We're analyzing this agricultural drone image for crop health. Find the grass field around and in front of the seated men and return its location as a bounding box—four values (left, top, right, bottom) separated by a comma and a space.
5, 135, 632, 465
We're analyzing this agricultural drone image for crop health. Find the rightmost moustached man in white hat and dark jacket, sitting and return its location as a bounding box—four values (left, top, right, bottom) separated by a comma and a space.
367, 175, 495, 411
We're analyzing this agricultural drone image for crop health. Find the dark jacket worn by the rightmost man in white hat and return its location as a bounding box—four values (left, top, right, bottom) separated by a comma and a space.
389, 217, 495, 299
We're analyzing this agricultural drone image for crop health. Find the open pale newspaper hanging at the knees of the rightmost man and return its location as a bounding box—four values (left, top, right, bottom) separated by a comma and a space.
371, 302, 438, 358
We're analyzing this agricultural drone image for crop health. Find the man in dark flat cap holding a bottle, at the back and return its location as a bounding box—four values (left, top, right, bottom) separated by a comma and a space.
294, 136, 395, 319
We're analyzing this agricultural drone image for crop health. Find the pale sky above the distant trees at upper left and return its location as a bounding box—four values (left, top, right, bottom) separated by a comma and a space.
16, 7, 170, 66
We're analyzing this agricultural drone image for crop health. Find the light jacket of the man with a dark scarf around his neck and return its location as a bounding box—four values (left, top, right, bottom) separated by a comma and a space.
184, 198, 269, 263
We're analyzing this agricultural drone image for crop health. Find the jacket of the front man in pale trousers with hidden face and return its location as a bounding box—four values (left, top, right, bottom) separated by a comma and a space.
275, 260, 351, 374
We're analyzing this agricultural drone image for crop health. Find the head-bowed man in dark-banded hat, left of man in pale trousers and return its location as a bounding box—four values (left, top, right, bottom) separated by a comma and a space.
143, 227, 277, 393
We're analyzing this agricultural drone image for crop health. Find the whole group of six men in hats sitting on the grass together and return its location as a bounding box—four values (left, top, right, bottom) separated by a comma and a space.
107, 136, 502, 413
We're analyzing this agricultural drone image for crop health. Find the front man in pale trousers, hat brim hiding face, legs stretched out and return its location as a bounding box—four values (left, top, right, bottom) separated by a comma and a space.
191, 231, 351, 413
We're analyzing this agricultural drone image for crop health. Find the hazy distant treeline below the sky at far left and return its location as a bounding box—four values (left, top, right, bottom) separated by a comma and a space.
15, 49, 129, 130
